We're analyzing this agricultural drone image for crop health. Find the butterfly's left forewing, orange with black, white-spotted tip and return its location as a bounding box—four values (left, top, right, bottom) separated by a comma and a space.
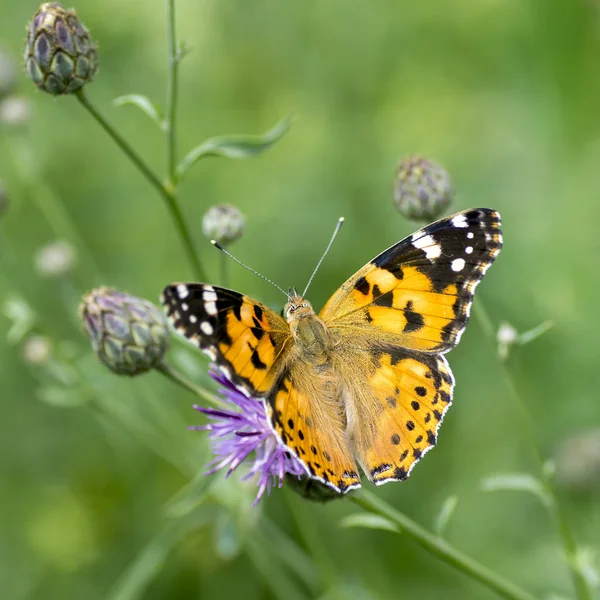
162, 283, 291, 397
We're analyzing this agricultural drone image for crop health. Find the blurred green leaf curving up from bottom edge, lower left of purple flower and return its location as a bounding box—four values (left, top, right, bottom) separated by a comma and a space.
107, 510, 213, 600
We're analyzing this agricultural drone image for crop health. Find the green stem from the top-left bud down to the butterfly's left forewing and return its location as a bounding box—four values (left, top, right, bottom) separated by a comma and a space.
75, 90, 206, 281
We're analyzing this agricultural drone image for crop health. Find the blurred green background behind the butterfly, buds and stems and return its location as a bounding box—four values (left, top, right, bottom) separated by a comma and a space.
0, 0, 600, 600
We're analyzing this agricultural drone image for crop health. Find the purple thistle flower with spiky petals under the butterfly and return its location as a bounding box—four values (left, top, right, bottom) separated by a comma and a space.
190, 370, 306, 505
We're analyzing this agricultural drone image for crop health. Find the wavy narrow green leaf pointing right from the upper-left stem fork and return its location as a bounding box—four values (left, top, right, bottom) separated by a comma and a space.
177, 117, 292, 180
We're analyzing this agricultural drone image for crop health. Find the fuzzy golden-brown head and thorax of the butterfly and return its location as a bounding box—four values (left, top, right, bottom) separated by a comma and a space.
284, 296, 333, 365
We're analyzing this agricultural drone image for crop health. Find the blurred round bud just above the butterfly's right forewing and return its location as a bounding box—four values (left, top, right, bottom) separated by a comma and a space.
394, 156, 454, 221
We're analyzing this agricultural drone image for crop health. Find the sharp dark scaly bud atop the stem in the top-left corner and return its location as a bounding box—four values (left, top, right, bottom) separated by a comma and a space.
25, 2, 98, 96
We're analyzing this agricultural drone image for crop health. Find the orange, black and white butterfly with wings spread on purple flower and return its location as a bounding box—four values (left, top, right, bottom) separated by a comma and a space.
162, 208, 502, 493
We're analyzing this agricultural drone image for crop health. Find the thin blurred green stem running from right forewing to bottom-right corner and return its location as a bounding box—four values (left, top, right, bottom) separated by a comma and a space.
473, 298, 594, 600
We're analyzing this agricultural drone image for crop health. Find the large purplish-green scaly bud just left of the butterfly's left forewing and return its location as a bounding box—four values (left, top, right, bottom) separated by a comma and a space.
79, 288, 169, 375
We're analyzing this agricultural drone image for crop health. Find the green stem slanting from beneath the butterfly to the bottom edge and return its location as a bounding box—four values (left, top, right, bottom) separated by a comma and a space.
350, 490, 535, 600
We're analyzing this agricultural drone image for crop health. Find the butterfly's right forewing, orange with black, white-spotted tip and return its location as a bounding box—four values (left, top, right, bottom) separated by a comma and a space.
320, 208, 502, 353
